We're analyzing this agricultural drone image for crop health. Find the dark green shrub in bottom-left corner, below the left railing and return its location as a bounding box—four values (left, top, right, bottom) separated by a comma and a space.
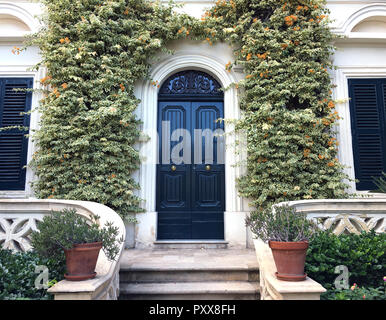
0, 249, 65, 300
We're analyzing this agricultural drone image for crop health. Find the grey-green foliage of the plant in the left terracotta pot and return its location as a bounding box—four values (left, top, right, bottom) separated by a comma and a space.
31, 209, 123, 260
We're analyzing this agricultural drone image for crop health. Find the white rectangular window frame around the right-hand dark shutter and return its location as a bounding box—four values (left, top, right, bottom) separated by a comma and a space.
334, 65, 386, 193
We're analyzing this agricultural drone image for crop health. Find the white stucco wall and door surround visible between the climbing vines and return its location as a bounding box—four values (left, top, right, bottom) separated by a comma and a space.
0, 0, 386, 247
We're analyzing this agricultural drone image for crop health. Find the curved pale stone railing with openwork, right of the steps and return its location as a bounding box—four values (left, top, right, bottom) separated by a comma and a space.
254, 198, 386, 300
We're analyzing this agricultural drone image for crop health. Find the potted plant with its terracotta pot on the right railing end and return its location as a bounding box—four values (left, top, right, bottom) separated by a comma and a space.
246, 205, 317, 281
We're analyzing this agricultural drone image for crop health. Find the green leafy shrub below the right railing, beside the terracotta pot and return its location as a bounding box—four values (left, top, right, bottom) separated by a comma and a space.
306, 231, 386, 290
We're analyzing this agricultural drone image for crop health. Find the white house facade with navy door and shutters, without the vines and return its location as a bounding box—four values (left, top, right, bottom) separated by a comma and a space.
0, 0, 386, 247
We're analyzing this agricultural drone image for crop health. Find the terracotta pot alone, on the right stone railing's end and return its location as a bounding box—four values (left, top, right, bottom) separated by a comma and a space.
269, 241, 308, 281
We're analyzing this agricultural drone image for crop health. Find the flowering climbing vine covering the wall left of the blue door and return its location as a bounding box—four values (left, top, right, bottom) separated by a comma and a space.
30, 0, 193, 217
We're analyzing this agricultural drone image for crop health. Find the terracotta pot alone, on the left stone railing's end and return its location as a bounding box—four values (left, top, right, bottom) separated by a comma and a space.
64, 242, 102, 281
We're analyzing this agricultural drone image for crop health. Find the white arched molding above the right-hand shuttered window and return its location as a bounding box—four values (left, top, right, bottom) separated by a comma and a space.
334, 3, 386, 40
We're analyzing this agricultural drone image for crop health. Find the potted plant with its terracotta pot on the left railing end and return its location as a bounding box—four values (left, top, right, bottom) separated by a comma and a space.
31, 209, 123, 281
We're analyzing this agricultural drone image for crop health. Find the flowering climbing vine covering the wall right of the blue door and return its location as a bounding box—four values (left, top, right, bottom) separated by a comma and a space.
202, 0, 348, 208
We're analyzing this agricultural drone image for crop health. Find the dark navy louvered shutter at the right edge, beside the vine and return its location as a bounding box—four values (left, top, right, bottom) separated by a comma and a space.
349, 79, 386, 190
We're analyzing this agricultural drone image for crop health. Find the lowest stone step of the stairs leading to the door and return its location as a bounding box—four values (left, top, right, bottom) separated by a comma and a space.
119, 281, 259, 300
